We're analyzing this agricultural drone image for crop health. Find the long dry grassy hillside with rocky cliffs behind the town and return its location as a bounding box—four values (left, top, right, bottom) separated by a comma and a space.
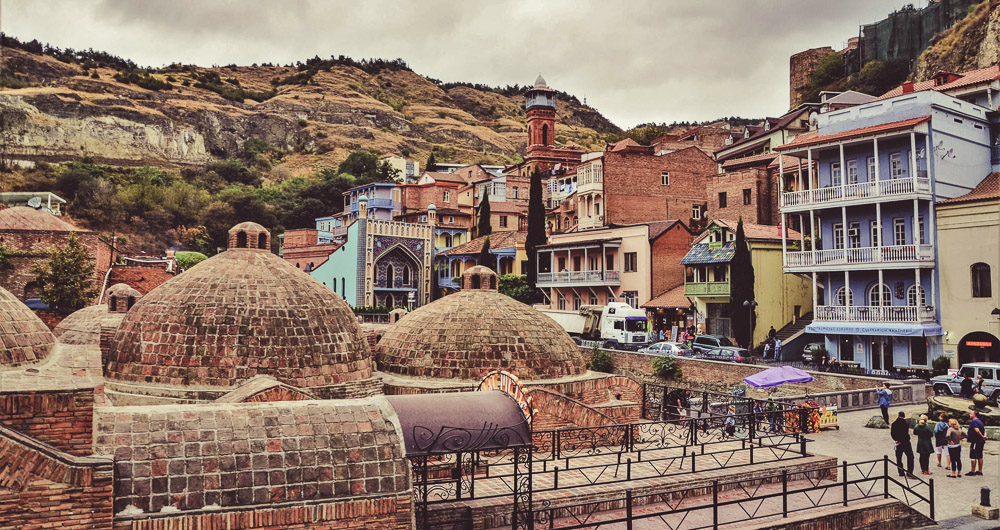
0, 42, 621, 175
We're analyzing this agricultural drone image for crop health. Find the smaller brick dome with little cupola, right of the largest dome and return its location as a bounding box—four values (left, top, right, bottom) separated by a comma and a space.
375, 266, 586, 379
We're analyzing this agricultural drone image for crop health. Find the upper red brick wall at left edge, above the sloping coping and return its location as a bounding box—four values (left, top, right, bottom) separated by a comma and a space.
0, 388, 94, 455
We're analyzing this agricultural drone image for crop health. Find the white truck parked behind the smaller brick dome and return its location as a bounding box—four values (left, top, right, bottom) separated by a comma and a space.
539, 302, 650, 351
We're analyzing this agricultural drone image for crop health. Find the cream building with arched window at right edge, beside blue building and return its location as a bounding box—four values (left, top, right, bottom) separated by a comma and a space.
936, 173, 1000, 368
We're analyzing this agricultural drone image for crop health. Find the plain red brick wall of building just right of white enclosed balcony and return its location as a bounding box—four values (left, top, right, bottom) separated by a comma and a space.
604, 147, 717, 226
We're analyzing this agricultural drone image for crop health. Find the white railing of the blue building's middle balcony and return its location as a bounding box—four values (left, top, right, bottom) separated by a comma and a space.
785, 245, 934, 272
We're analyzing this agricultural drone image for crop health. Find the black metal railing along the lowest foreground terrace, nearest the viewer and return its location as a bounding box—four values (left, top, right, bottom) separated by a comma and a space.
532, 456, 934, 530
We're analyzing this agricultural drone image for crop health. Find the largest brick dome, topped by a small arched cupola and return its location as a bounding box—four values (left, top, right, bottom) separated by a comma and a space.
102, 223, 381, 404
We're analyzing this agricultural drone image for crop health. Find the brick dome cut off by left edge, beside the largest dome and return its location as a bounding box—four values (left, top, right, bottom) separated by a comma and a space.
0, 287, 56, 366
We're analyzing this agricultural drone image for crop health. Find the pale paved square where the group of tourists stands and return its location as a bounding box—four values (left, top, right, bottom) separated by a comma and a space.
809, 405, 1000, 529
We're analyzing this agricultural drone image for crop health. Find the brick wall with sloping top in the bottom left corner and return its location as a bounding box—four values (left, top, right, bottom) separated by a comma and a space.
0, 429, 113, 530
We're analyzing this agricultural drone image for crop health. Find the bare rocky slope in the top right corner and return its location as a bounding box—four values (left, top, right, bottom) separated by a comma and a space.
913, 0, 1000, 81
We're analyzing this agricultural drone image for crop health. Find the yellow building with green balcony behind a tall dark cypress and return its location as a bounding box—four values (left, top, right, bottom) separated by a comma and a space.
681, 219, 812, 345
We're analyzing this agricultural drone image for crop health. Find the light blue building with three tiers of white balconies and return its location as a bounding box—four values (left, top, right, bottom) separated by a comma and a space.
777, 83, 996, 372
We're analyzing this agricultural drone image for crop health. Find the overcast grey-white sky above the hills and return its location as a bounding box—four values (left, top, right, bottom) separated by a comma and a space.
2, 0, 926, 127
